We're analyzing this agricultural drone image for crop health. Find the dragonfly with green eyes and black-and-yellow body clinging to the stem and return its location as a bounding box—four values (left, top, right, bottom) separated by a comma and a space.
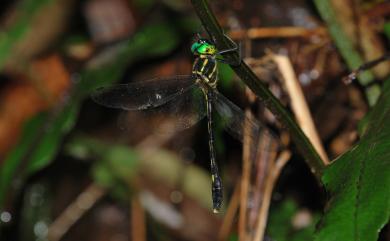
92, 38, 277, 213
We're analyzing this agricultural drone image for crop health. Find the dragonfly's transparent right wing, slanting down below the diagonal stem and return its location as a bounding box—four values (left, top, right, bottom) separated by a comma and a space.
212, 90, 278, 146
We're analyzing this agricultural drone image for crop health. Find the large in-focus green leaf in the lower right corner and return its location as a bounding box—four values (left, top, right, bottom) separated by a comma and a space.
315, 81, 390, 241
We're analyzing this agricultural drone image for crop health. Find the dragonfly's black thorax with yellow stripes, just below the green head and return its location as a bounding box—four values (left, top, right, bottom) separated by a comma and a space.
192, 55, 218, 88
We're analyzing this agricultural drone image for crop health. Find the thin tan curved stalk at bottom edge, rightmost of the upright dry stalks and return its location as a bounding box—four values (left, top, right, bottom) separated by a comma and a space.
253, 151, 291, 241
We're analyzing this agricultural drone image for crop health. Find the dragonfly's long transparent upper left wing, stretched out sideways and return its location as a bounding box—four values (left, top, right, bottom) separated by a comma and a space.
91, 75, 195, 110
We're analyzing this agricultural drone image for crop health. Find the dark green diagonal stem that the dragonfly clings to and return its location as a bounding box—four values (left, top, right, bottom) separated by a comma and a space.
191, 0, 325, 181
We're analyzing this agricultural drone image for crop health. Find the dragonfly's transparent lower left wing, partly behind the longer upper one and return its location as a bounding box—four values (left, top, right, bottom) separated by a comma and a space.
118, 84, 206, 133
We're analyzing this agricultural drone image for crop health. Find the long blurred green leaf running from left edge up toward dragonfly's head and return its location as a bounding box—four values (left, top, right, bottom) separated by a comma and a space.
0, 24, 178, 208
